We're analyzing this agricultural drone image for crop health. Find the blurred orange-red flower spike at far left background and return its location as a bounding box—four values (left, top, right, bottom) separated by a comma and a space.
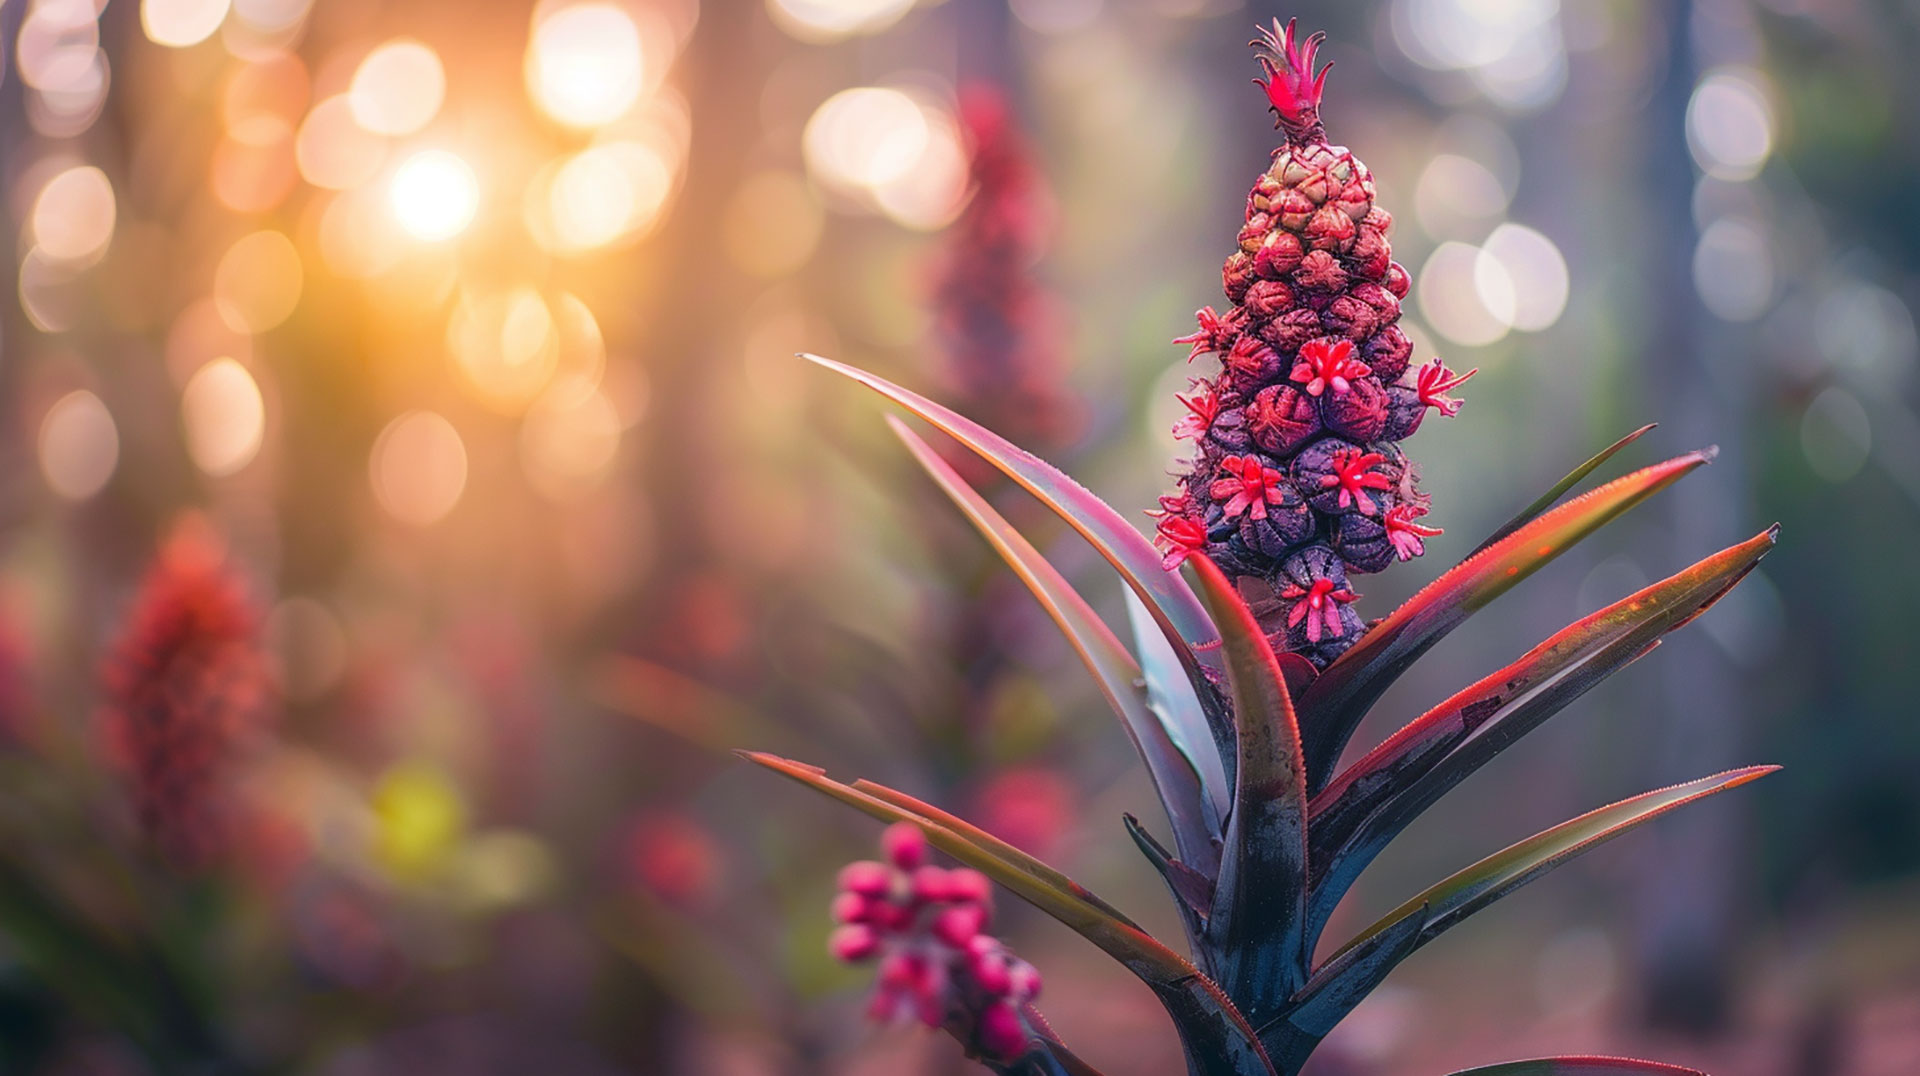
102, 525, 267, 868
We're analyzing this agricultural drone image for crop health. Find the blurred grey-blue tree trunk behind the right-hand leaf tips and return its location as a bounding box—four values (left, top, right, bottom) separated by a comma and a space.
1636, 0, 1751, 1034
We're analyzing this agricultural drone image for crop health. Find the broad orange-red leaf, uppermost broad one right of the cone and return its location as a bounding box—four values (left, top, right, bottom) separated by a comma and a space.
1300, 450, 1713, 792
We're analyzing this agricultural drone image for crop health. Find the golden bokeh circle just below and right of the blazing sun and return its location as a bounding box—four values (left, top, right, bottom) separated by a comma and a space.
447, 288, 561, 413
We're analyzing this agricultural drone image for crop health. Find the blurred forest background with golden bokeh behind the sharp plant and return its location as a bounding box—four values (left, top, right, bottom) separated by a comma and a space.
0, 0, 1920, 1076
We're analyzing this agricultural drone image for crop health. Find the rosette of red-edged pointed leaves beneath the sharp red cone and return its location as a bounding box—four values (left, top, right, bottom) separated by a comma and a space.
743, 21, 1776, 1076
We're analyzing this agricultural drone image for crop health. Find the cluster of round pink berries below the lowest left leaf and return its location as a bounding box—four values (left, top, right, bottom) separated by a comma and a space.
828, 822, 1041, 1061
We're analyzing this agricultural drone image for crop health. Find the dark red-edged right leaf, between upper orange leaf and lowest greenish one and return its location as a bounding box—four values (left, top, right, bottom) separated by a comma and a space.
1308, 526, 1778, 942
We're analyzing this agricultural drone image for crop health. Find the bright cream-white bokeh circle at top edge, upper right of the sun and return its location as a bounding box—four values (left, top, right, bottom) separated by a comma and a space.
526, 4, 643, 127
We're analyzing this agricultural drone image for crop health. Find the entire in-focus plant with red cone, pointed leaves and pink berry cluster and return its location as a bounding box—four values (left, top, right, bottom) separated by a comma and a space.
743, 23, 1776, 1076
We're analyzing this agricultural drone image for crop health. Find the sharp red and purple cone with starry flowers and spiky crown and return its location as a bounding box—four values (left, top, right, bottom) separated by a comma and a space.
1158, 23, 1473, 667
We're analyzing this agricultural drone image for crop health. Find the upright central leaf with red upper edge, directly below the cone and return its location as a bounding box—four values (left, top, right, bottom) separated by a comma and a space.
1188, 553, 1311, 1020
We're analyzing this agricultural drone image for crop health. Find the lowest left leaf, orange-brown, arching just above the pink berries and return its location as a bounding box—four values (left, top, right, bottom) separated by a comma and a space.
739, 751, 1275, 1076
